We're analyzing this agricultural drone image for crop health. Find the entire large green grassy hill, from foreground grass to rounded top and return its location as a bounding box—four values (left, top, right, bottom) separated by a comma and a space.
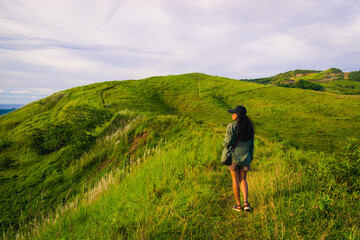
0, 73, 360, 239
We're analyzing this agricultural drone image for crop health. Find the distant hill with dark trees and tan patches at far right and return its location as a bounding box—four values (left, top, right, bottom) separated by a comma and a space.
245, 68, 360, 95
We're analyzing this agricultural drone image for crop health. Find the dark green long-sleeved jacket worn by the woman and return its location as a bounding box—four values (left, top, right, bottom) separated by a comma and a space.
223, 122, 254, 166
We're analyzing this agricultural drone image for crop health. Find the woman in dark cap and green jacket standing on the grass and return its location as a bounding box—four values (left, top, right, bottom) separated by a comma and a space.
223, 106, 254, 211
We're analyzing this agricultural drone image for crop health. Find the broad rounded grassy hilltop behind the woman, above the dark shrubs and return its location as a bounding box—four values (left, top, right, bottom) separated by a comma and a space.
0, 74, 360, 150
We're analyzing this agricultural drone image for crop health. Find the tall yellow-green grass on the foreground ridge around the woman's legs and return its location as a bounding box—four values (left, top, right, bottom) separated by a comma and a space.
12, 119, 360, 239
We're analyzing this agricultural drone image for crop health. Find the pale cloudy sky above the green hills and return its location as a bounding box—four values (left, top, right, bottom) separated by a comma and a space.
0, 0, 360, 103
